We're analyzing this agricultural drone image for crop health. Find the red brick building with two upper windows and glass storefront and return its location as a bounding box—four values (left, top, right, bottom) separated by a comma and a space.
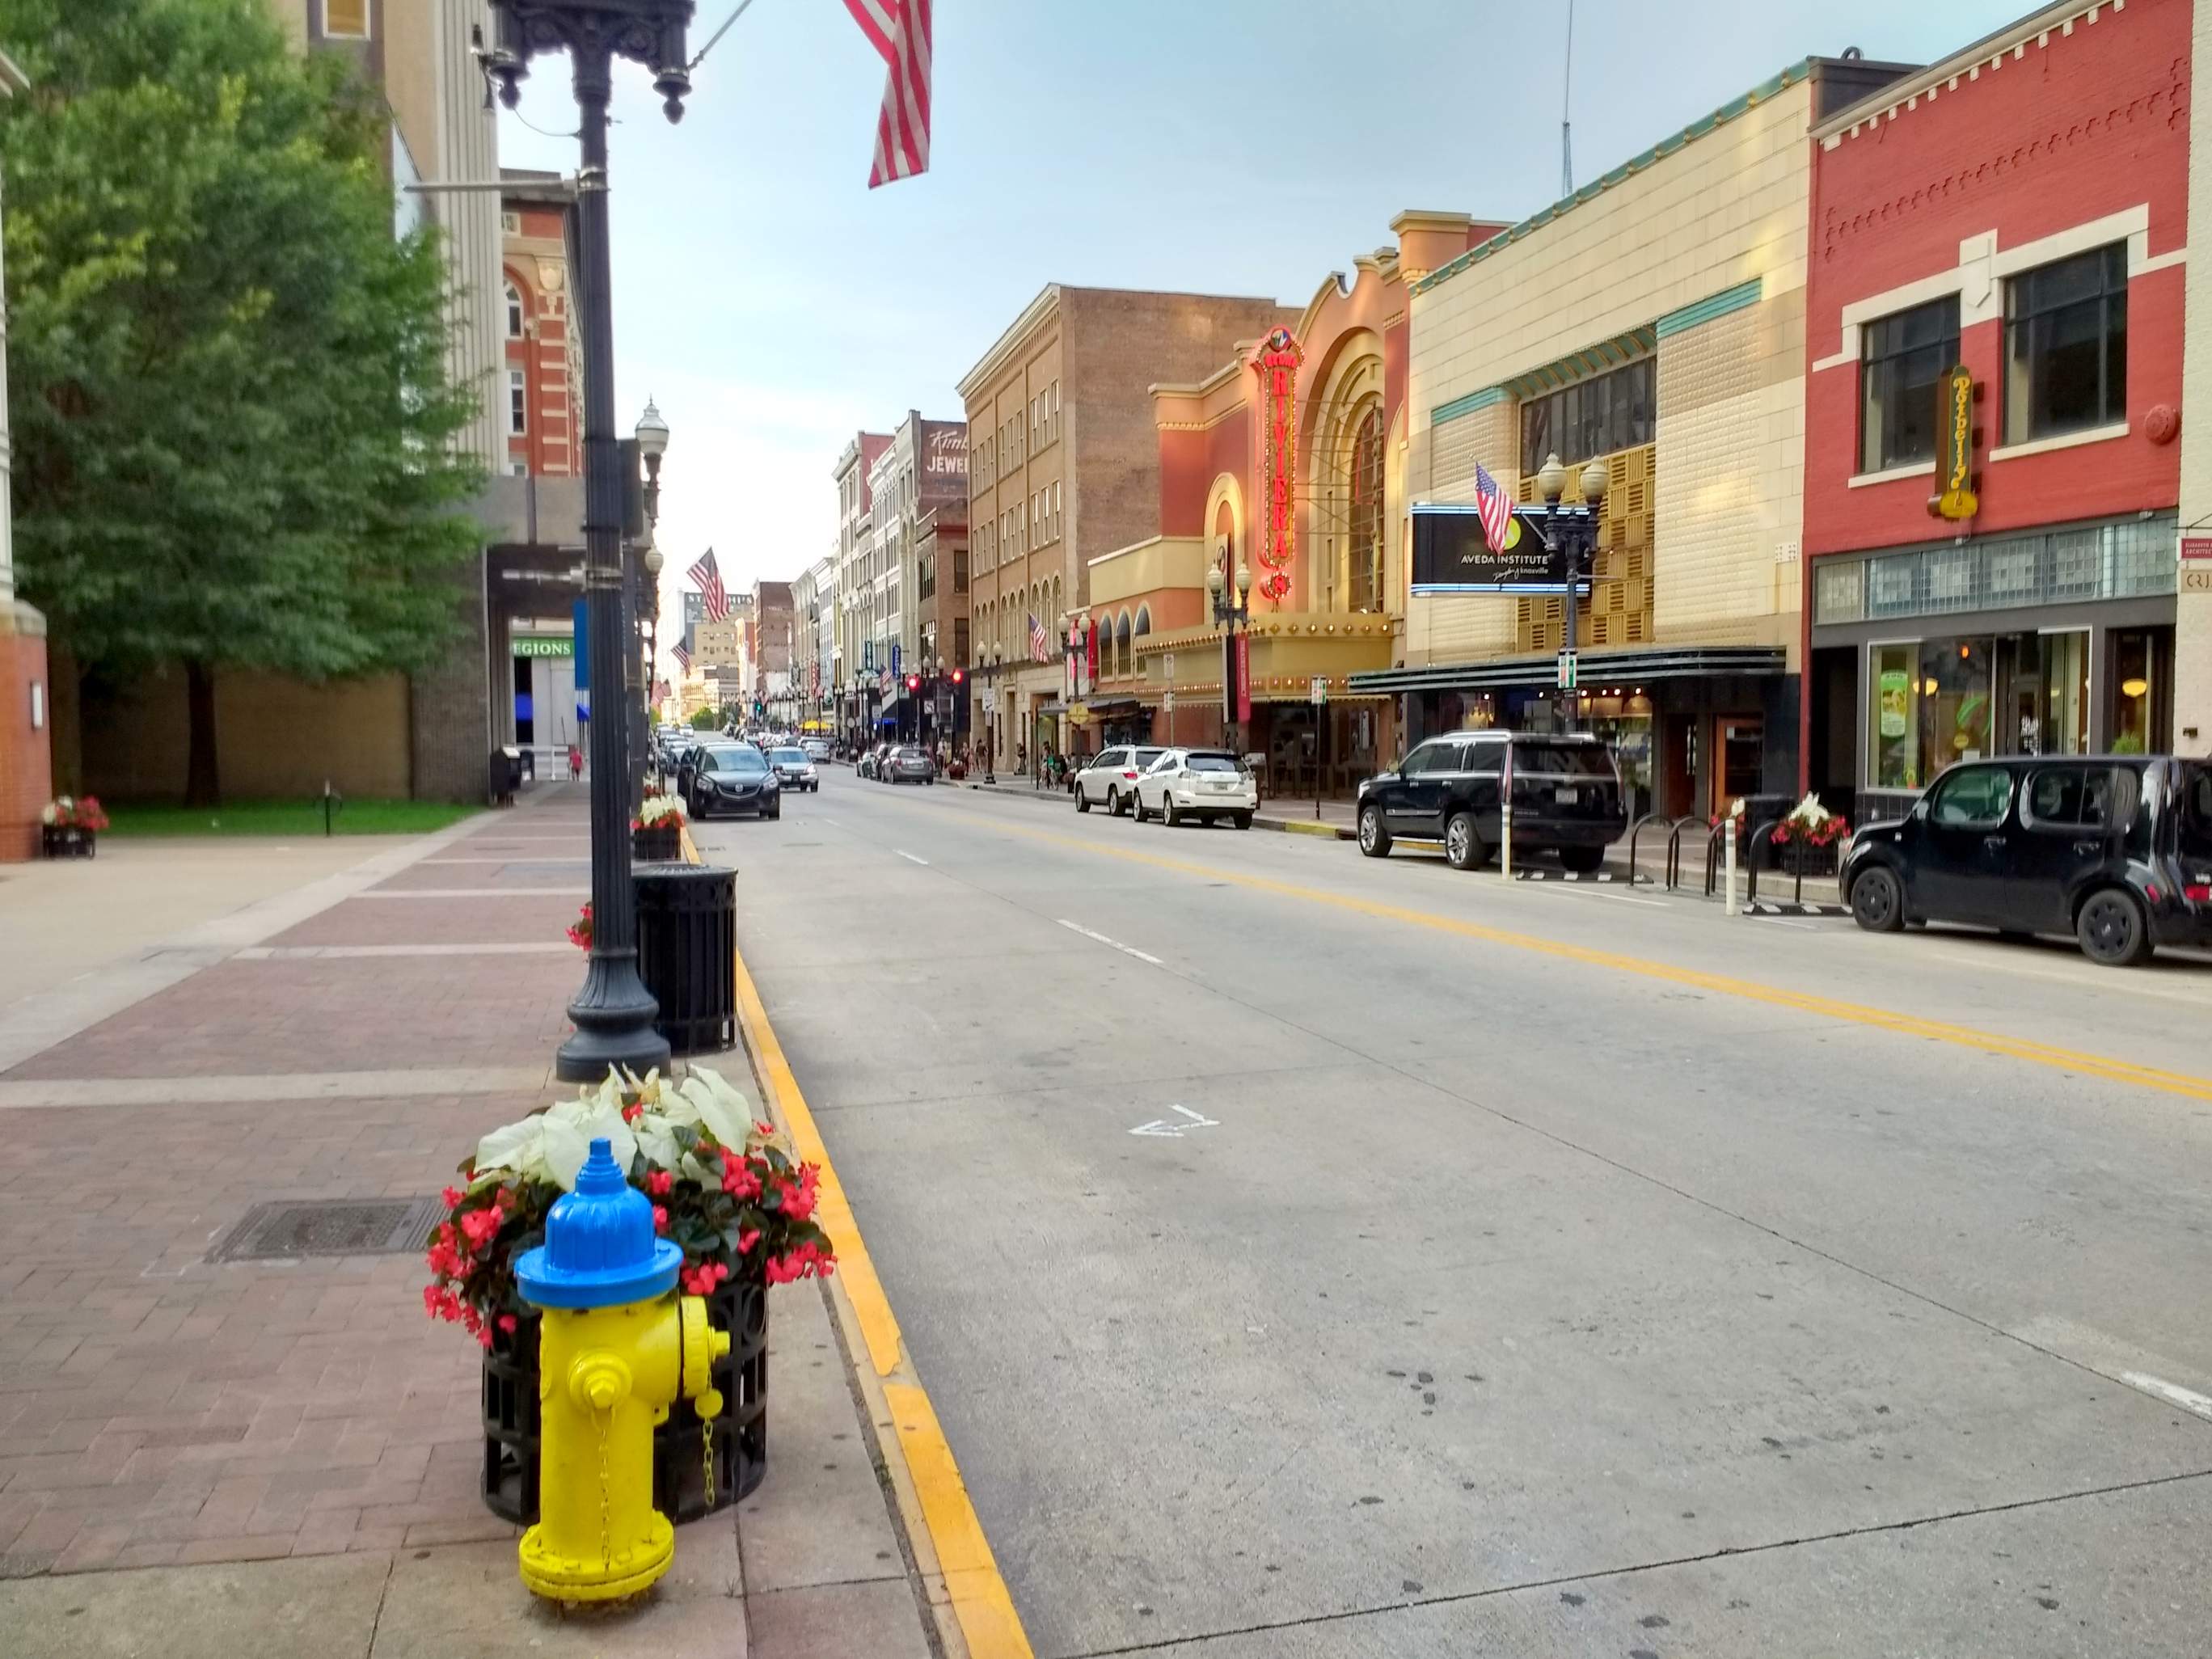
1800, 0, 2190, 809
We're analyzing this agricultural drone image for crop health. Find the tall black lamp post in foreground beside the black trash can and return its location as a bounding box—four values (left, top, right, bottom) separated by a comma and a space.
484, 0, 692, 1082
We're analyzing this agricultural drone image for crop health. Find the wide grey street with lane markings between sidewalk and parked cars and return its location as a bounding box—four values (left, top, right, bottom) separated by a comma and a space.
697, 767, 2212, 1659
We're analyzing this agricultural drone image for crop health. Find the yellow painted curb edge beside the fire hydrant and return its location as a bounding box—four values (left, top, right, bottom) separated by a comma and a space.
734, 951, 1033, 1659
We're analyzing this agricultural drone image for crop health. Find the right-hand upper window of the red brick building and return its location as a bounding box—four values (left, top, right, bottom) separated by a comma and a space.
2004, 241, 2128, 445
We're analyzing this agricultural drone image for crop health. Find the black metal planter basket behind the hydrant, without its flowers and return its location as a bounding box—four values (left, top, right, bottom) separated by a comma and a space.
482, 1259, 767, 1526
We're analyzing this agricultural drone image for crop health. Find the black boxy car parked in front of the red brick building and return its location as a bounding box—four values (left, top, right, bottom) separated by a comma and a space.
1840, 754, 2212, 967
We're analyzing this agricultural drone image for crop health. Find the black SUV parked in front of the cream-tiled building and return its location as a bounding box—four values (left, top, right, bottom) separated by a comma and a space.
1358, 732, 1628, 874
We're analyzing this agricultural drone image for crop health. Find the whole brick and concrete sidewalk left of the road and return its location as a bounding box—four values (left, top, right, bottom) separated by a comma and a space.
0, 785, 934, 1659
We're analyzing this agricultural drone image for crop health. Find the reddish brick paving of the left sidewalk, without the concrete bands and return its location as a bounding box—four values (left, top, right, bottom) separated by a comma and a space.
0, 792, 589, 1577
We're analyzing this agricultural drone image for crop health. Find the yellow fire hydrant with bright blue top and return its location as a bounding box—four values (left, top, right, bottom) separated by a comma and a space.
515, 1139, 730, 1602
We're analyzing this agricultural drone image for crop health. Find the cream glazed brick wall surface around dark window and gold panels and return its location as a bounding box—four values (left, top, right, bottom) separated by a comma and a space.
1407, 60, 1898, 668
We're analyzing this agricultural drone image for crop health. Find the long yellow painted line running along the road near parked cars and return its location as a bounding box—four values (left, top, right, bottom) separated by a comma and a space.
989, 823, 2212, 1100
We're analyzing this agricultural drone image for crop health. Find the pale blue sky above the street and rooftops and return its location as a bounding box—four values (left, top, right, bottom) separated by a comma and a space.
500, 0, 2028, 677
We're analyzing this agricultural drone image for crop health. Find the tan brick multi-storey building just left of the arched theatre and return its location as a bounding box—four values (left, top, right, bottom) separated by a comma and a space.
960, 283, 1296, 767
